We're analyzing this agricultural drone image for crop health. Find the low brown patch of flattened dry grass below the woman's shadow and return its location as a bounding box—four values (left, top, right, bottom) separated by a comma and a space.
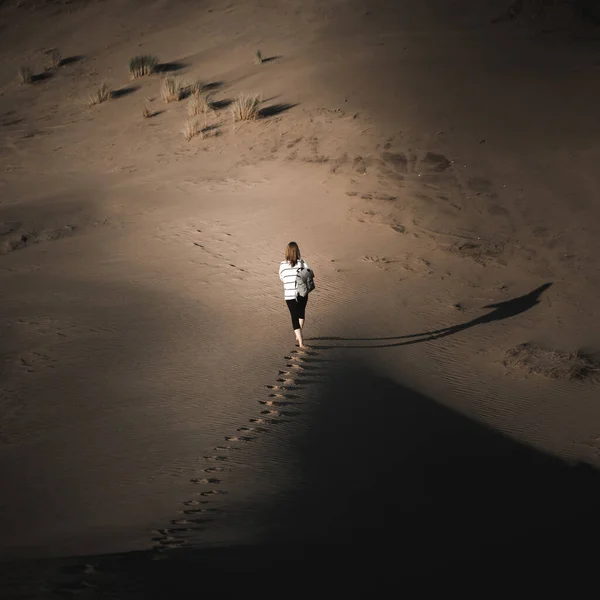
504, 343, 600, 379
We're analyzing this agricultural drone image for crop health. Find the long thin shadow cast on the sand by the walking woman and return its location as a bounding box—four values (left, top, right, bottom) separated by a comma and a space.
307, 283, 552, 350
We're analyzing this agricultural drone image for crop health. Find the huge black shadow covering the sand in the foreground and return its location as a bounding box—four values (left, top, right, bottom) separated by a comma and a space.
10, 356, 600, 599
